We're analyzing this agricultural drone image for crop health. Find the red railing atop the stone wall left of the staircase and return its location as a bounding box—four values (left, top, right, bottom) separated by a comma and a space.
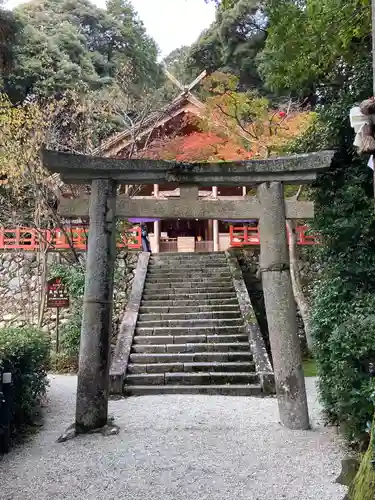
0, 227, 142, 251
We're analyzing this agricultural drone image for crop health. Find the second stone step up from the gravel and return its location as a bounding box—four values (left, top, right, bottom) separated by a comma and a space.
125, 372, 259, 385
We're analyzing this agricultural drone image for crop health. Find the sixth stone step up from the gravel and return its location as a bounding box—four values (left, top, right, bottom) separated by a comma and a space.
133, 333, 248, 345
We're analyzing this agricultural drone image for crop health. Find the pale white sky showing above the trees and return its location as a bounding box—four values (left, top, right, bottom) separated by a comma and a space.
5, 0, 215, 57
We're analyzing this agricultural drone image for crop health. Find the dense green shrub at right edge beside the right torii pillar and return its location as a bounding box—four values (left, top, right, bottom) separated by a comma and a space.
312, 278, 375, 441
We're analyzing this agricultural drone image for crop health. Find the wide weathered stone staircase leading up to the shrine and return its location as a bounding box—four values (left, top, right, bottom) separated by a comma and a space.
124, 253, 262, 396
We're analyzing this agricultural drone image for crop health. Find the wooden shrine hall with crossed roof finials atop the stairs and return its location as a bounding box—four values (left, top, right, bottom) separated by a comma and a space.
87, 70, 311, 253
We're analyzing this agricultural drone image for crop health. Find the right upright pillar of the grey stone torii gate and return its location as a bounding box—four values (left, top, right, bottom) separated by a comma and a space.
258, 182, 309, 429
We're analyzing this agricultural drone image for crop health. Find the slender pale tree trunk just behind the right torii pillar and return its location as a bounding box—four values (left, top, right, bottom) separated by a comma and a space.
287, 220, 314, 353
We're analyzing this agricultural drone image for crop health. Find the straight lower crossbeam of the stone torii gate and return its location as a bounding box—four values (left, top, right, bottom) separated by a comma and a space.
59, 196, 314, 220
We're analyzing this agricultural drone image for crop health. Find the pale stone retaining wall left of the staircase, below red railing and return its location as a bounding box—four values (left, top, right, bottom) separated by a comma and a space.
0, 251, 138, 332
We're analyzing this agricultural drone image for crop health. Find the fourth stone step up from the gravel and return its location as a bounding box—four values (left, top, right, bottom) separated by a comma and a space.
130, 349, 253, 364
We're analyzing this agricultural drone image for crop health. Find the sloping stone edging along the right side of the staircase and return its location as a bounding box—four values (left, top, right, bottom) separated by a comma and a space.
225, 252, 275, 394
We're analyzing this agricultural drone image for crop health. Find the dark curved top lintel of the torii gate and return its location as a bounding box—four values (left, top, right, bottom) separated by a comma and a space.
42, 150, 334, 186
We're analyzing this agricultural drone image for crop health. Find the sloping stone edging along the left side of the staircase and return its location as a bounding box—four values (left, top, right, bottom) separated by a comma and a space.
109, 252, 150, 394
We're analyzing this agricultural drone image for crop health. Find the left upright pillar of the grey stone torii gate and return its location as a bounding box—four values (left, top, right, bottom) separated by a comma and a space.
76, 180, 116, 433
